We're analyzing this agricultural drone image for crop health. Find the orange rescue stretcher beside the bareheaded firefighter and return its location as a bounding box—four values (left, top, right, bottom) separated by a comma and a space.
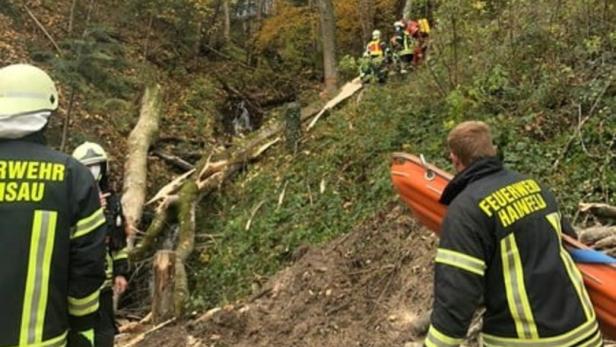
391, 153, 616, 339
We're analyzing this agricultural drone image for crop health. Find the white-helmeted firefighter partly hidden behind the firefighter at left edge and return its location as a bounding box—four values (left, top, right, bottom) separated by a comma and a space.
73, 142, 129, 347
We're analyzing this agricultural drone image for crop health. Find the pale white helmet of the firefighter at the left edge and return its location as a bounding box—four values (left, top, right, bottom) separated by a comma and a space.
0, 64, 58, 139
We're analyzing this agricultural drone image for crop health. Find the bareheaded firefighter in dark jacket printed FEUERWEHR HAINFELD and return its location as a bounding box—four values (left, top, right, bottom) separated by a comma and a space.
424, 121, 602, 347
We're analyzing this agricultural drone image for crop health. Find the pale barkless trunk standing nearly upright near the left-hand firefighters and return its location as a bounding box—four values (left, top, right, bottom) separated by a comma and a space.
122, 84, 162, 248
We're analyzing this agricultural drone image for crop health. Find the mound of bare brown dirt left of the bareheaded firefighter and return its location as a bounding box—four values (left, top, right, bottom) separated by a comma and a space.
140, 206, 435, 347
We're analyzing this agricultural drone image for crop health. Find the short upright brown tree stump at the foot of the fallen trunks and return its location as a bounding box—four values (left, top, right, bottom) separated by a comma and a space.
152, 250, 177, 324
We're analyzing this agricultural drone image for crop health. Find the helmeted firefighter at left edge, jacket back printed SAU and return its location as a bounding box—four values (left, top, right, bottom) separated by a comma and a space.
0, 64, 105, 347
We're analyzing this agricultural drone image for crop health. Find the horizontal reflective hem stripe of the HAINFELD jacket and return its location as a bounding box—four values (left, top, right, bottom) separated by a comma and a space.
482, 320, 599, 347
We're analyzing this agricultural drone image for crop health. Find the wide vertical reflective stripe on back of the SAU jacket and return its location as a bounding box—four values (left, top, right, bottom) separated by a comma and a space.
19, 210, 57, 346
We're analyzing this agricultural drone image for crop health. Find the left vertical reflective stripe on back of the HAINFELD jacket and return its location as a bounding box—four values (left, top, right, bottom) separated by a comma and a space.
501, 233, 539, 339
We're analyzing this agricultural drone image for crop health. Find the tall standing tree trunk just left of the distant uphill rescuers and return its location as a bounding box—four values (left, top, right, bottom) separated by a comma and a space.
318, 0, 338, 95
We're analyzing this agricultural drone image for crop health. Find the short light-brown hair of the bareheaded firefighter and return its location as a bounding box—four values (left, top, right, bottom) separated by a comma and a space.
447, 121, 496, 166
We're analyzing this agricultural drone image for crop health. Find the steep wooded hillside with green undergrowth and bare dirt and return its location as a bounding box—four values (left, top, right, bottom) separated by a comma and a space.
0, 0, 616, 346
